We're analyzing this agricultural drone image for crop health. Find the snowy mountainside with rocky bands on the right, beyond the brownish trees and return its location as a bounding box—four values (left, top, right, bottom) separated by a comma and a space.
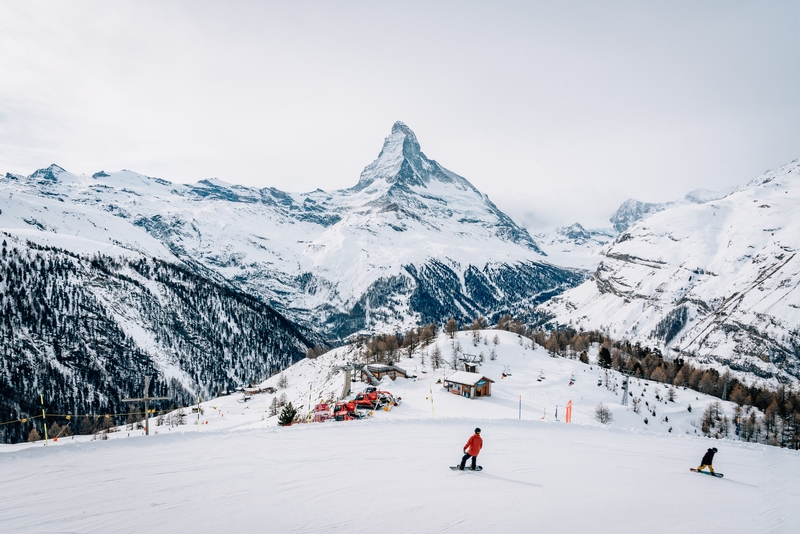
544, 160, 800, 382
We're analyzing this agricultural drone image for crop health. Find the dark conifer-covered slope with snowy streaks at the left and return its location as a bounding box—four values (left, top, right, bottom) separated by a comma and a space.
0, 235, 310, 442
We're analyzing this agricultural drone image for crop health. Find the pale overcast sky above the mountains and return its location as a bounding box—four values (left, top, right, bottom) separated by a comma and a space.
0, 0, 800, 231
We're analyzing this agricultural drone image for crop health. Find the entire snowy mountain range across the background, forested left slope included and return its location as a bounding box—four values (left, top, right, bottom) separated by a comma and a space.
0, 122, 800, 428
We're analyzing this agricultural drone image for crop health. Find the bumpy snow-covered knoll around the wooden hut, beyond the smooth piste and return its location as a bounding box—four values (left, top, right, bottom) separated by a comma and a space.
181, 330, 776, 439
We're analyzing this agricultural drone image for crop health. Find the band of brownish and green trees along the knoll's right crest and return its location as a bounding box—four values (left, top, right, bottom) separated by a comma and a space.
356, 314, 800, 450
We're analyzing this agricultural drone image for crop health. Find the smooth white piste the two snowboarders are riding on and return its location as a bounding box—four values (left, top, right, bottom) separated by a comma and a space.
0, 419, 800, 534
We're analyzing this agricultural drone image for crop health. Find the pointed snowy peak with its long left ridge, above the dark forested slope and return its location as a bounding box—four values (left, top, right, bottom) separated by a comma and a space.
0, 122, 584, 340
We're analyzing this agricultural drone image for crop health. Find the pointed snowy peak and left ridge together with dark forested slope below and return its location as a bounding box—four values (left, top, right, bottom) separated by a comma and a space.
0, 122, 586, 439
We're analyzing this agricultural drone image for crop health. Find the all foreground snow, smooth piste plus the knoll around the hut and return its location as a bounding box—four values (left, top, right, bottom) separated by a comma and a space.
0, 331, 800, 534
